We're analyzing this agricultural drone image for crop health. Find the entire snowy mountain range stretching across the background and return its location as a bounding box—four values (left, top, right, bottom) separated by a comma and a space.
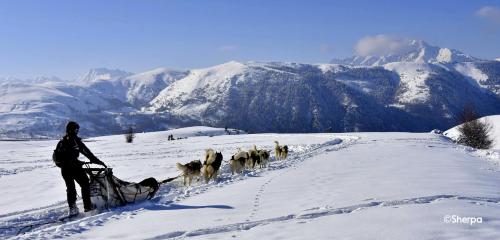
0, 40, 500, 138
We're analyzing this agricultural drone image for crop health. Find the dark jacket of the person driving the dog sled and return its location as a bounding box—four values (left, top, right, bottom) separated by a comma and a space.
60, 135, 105, 168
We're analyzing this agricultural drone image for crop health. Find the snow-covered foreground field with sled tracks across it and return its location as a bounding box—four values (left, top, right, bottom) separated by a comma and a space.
0, 128, 500, 239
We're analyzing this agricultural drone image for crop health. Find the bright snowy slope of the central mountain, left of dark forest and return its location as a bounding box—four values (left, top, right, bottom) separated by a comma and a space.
148, 61, 314, 119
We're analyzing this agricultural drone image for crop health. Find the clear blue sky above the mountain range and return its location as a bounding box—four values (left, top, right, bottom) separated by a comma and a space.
0, 0, 500, 78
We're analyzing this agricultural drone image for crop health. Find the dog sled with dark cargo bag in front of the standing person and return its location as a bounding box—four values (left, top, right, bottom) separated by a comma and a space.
85, 166, 177, 210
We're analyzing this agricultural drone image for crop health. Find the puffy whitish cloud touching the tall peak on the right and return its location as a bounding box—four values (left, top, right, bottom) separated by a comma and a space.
354, 34, 412, 56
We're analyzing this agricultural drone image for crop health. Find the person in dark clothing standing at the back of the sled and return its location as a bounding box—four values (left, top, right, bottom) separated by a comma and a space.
52, 122, 106, 216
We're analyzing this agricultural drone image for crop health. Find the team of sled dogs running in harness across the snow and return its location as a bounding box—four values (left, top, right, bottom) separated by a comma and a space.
176, 141, 288, 185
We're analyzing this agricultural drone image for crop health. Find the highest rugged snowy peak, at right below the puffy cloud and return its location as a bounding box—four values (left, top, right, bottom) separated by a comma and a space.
331, 40, 479, 66
